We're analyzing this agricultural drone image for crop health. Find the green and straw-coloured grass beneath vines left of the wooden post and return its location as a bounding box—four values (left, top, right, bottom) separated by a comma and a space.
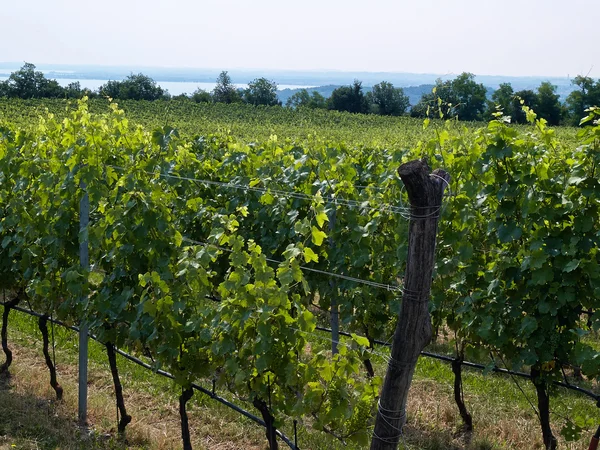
0, 312, 263, 450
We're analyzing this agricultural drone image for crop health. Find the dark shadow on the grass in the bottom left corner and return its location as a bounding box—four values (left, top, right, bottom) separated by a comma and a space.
0, 373, 144, 450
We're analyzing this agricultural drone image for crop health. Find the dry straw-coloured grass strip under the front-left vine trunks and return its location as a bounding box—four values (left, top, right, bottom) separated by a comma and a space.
0, 344, 264, 450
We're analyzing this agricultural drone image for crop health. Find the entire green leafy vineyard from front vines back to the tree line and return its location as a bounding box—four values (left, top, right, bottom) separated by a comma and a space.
0, 99, 600, 449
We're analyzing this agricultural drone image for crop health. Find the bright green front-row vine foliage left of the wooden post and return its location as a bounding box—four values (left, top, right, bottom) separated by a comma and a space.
0, 100, 380, 440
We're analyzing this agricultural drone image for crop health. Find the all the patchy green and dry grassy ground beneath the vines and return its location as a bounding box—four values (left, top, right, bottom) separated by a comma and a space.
0, 304, 600, 450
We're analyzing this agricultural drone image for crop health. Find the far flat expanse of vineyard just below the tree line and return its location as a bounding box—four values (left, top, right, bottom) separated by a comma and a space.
0, 99, 577, 155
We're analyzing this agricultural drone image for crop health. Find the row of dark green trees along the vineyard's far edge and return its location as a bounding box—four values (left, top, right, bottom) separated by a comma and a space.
0, 63, 600, 125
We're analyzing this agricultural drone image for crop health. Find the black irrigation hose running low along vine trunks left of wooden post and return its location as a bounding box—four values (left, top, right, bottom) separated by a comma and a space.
0, 302, 300, 450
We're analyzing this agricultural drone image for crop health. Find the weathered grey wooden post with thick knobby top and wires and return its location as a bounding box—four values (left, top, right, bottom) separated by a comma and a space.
371, 160, 450, 450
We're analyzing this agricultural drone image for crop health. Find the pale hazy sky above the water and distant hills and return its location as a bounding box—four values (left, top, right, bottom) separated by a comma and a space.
0, 0, 600, 78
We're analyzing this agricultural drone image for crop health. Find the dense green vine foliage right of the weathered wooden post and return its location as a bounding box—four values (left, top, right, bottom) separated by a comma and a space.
434, 108, 599, 386
